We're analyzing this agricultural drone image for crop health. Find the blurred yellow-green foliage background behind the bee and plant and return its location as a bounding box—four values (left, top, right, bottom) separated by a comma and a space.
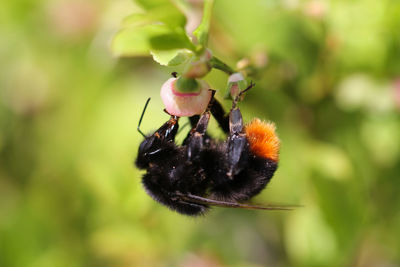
0, 0, 400, 267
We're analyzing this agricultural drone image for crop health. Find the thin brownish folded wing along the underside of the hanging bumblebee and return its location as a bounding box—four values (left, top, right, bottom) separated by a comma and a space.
181, 194, 297, 213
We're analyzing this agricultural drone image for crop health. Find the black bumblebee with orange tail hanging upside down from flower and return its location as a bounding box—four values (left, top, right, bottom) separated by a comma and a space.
135, 83, 289, 216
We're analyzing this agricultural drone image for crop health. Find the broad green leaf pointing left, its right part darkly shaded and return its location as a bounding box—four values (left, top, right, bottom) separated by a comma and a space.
111, 25, 194, 56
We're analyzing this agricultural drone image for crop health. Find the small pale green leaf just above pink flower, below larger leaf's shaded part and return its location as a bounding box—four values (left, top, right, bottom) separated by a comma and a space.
150, 49, 193, 67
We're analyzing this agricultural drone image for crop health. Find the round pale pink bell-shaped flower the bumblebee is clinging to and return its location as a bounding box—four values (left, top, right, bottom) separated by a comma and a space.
161, 78, 211, 117
